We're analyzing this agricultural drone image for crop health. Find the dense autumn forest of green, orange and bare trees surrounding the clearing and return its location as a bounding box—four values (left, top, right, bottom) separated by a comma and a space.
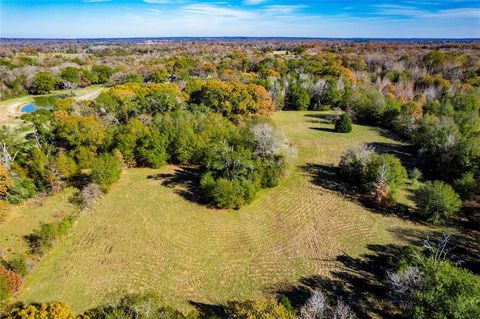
0, 40, 480, 319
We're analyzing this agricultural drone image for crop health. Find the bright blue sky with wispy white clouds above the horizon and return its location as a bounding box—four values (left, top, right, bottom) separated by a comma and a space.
0, 0, 480, 38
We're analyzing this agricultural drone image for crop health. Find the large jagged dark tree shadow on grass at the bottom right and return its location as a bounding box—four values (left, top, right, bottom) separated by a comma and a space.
272, 244, 408, 318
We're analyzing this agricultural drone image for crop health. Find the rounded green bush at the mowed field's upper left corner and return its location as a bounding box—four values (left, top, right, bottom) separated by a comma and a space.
91, 153, 122, 189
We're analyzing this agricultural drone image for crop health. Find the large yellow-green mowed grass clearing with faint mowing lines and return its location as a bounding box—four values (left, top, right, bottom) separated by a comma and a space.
18, 112, 426, 312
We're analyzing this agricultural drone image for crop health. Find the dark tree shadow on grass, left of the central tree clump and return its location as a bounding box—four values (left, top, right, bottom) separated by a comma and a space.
147, 167, 208, 205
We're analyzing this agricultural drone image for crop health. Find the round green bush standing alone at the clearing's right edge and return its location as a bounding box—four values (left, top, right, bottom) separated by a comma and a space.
414, 181, 462, 223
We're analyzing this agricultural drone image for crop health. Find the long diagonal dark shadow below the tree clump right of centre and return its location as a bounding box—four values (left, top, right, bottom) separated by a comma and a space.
300, 163, 416, 222
